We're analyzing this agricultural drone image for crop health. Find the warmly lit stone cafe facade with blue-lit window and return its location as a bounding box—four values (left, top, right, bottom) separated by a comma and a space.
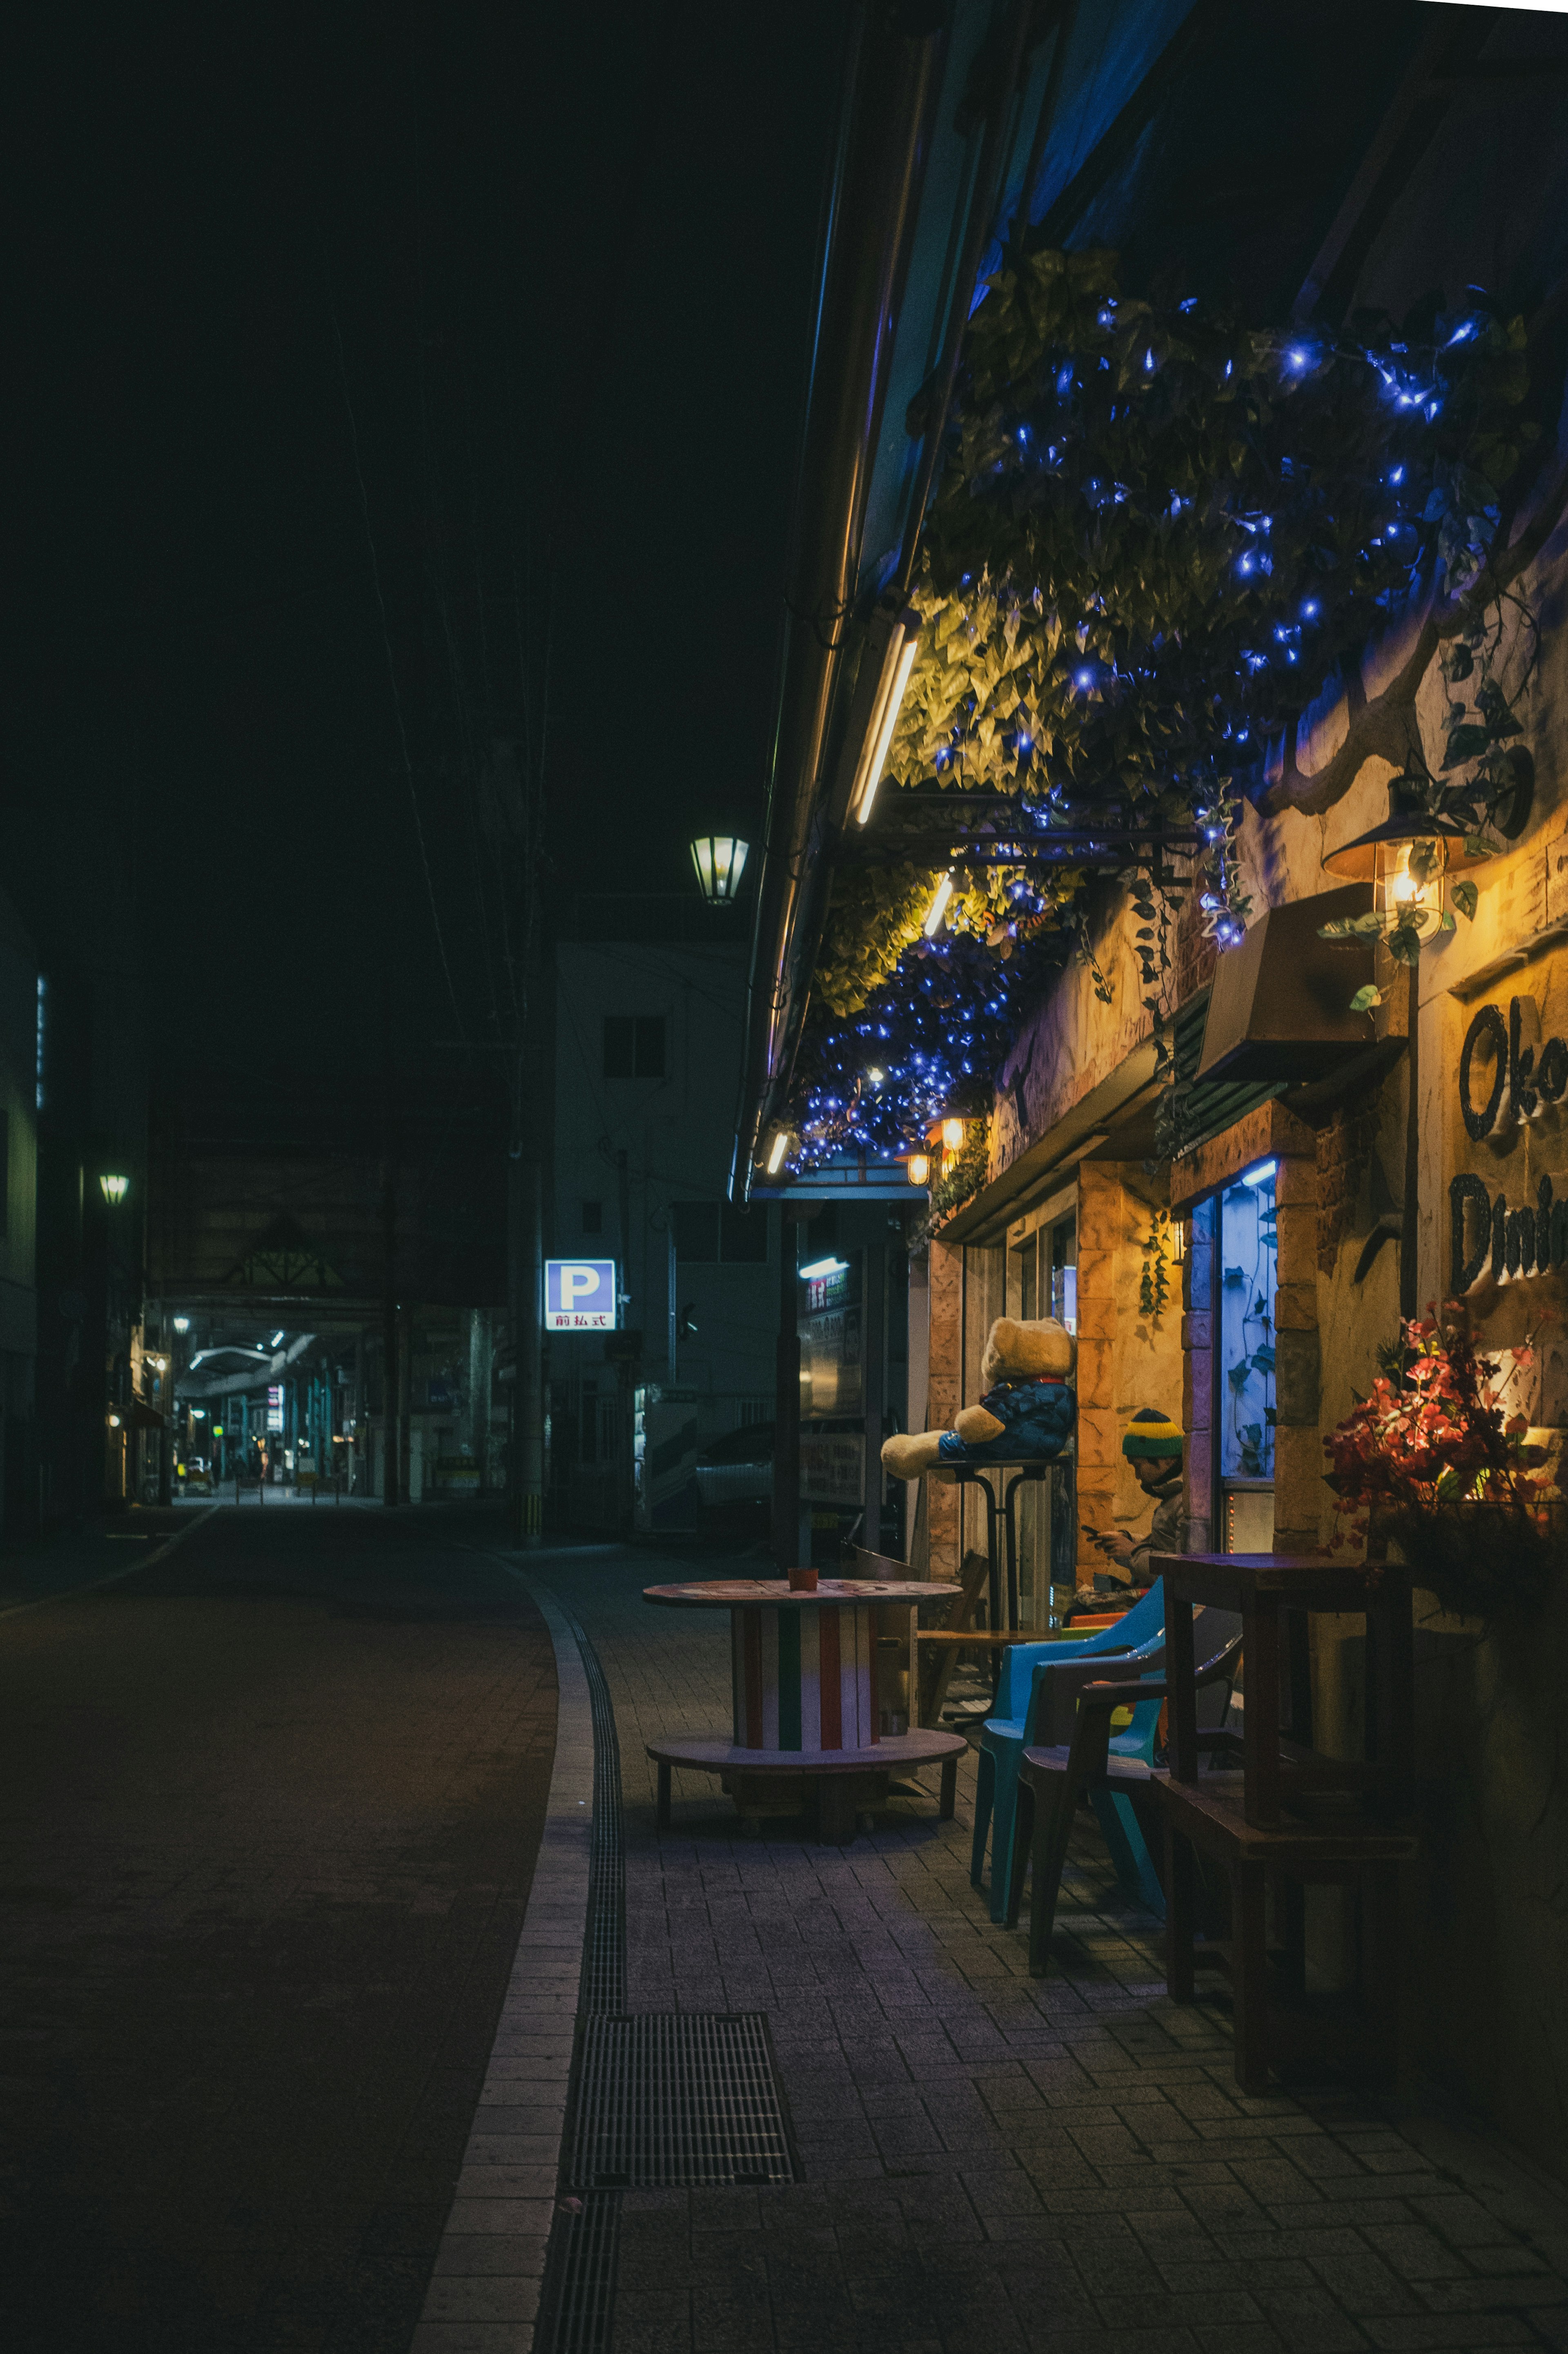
911, 546, 1568, 2170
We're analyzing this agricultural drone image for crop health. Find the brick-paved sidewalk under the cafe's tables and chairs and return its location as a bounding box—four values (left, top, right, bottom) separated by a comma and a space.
530, 1549, 1568, 2354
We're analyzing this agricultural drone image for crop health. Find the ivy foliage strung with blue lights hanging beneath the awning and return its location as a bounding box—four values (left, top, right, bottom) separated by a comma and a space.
796, 252, 1535, 1156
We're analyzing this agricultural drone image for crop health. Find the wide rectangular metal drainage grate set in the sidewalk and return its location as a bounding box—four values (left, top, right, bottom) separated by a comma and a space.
565, 2010, 800, 2191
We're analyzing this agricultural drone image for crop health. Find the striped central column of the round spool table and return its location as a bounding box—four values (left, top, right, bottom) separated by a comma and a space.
730, 1603, 878, 1754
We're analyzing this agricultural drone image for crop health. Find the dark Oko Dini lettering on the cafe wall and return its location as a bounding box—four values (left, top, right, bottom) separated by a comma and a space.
1448, 998, 1568, 1297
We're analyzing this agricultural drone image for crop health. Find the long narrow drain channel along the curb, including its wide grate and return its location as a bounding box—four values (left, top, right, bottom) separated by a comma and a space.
535, 1596, 800, 2354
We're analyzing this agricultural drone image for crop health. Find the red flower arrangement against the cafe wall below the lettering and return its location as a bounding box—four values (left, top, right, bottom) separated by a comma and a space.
1323, 1311, 1563, 1620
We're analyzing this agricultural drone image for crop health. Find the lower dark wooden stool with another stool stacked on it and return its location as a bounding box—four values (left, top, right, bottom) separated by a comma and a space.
1151, 1770, 1415, 2093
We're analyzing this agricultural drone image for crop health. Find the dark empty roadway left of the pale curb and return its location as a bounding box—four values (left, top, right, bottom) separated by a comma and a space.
0, 1507, 556, 2354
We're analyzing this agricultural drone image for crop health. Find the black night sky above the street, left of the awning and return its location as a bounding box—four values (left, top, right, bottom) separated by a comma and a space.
2, 5, 843, 1120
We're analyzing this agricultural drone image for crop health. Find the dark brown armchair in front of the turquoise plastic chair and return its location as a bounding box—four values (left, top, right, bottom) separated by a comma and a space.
1005, 1610, 1241, 1977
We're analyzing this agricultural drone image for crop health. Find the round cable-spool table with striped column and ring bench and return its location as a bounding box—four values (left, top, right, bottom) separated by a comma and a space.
643, 1577, 968, 1846
